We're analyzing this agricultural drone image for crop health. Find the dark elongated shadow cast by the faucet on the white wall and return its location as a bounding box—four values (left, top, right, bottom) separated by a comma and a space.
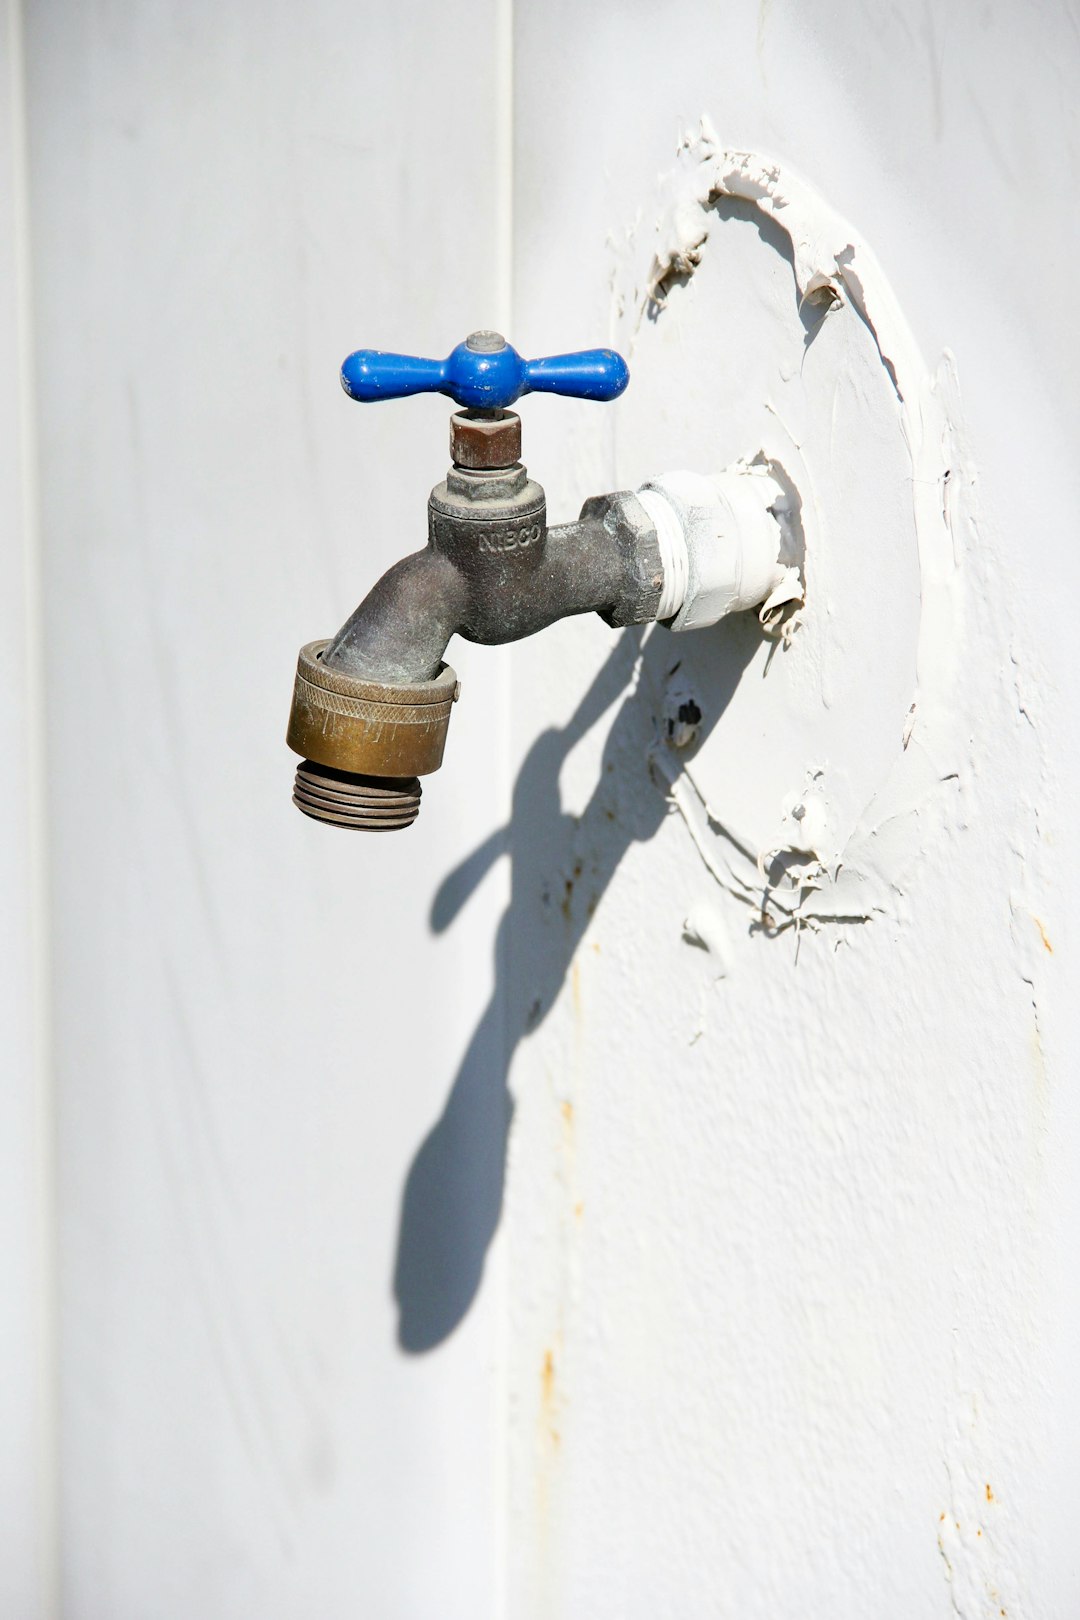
393, 614, 763, 1354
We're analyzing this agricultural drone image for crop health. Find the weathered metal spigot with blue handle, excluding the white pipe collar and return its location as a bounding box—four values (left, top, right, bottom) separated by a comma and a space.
287, 332, 641, 831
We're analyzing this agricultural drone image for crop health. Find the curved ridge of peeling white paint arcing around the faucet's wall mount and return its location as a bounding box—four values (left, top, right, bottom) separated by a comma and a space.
623, 129, 976, 920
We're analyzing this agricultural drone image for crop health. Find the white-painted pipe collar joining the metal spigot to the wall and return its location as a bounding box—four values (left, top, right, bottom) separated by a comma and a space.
636, 465, 789, 630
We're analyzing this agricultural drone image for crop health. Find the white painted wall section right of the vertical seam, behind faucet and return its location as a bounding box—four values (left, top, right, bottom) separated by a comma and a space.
507, 3, 1080, 1620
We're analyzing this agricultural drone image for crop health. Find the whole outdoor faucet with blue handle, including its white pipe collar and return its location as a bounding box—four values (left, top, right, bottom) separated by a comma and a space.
287, 332, 801, 831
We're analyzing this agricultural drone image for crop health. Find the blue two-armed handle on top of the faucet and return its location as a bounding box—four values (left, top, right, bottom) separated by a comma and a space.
342, 332, 630, 410
